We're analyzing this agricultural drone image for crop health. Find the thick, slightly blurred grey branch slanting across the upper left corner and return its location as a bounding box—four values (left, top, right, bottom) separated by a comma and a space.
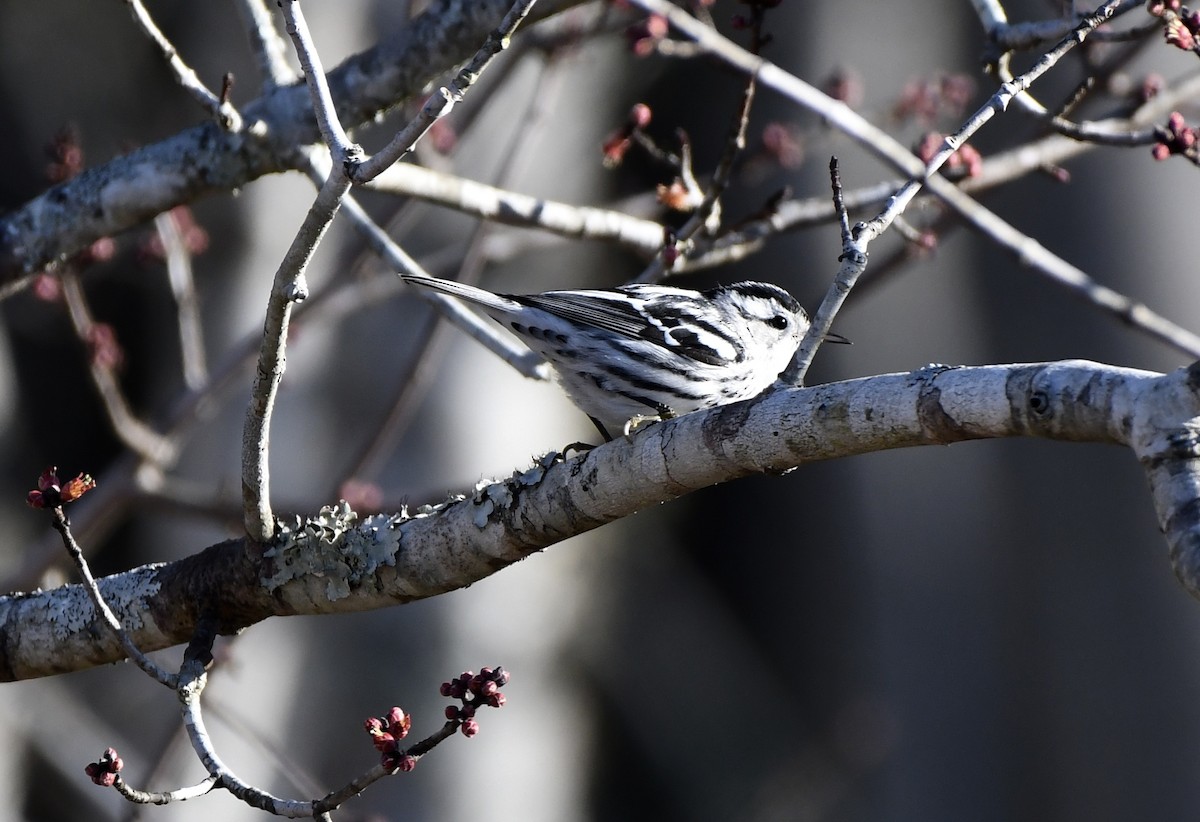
0, 0, 574, 287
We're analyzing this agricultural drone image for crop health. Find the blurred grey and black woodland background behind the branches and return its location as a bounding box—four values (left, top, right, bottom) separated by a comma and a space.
0, 0, 1200, 822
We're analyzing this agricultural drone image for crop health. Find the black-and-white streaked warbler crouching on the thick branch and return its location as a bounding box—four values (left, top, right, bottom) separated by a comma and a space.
403, 275, 809, 439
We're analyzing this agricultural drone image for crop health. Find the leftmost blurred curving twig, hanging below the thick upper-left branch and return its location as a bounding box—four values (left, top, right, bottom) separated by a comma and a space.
61, 271, 175, 464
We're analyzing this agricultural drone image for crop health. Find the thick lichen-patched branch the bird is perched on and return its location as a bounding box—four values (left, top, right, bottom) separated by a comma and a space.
0, 361, 1200, 680
